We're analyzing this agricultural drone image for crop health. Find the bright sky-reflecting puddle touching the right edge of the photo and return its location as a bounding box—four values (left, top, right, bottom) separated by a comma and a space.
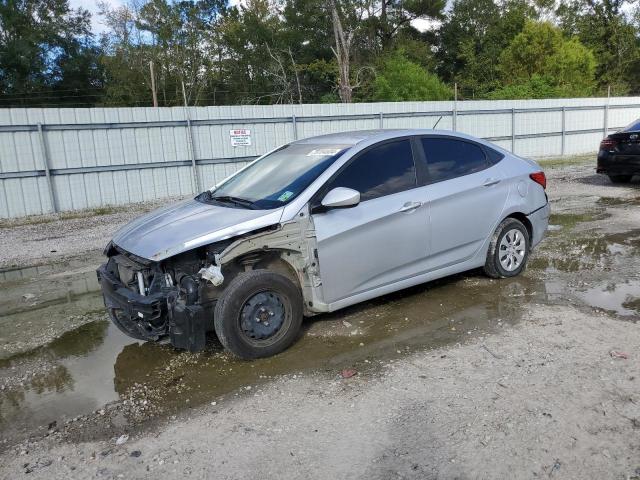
578, 280, 640, 319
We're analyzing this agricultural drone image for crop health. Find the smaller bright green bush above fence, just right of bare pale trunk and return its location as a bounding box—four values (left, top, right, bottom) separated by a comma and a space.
371, 52, 453, 102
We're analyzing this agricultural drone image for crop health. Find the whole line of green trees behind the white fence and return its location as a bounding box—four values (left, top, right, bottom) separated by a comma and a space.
0, 0, 640, 106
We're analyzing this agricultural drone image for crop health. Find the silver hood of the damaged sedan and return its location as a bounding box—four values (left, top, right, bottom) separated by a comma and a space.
113, 200, 283, 261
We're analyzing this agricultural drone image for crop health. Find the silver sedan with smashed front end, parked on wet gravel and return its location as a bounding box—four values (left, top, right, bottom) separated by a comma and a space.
98, 130, 549, 358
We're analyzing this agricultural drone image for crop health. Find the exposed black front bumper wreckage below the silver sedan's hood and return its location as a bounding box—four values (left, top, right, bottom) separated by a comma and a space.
97, 245, 215, 352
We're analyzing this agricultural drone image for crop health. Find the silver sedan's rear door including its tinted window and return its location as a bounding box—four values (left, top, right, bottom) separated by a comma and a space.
419, 136, 509, 270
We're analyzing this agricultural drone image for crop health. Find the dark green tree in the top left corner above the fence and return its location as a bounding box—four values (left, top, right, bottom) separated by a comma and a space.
0, 0, 102, 105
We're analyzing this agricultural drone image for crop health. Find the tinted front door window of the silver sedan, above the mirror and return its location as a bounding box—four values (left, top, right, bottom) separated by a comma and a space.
329, 140, 416, 201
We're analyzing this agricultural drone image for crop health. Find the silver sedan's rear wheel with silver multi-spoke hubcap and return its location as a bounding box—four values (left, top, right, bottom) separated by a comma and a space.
484, 217, 530, 278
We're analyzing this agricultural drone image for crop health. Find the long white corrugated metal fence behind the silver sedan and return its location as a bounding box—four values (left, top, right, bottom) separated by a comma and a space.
0, 97, 640, 218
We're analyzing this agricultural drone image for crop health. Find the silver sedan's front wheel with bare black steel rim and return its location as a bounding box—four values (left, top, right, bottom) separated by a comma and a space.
214, 270, 303, 360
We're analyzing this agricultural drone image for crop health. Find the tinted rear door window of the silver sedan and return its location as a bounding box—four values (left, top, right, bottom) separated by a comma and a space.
421, 137, 489, 182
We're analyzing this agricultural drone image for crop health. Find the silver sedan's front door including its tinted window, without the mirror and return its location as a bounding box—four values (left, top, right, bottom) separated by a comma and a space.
313, 138, 428, 303
